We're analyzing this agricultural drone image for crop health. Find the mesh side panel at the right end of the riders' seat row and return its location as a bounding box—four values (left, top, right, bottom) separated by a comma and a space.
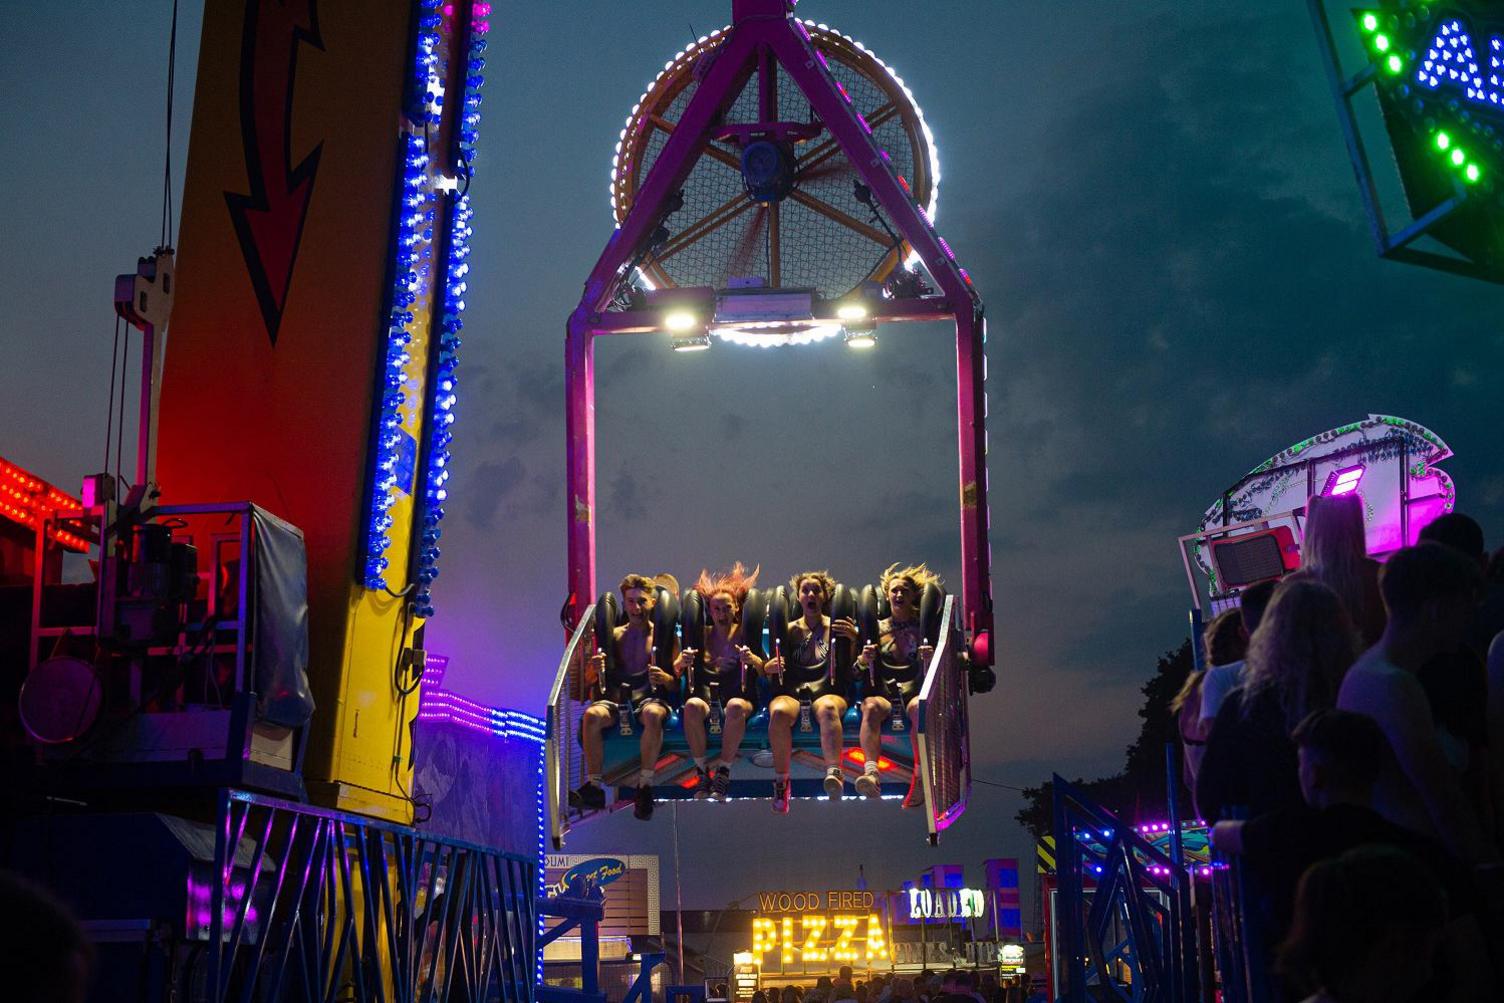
916, 595, 972, 842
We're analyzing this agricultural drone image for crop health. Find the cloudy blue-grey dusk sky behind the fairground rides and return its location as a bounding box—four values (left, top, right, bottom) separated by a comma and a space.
0, 0, 1504, 926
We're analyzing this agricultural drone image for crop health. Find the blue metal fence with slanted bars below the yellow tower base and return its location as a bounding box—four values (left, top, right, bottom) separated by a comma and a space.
203, 791, 538, 1003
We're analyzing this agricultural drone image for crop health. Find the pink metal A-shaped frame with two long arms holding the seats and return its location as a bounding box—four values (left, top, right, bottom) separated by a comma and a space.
564, 0, 993, 662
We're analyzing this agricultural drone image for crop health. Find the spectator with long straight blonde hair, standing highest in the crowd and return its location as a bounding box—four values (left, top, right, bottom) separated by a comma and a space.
1301, 493, 1385, 647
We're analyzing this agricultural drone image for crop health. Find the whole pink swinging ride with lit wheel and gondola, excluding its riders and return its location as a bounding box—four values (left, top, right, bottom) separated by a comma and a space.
547, 0, 993, 845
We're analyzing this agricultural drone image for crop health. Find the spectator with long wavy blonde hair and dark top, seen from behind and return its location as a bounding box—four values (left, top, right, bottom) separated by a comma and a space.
1196, 574, 1357, 820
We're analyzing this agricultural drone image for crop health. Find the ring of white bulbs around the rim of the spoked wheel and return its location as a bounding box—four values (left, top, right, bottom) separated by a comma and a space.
608, 20, 940, 289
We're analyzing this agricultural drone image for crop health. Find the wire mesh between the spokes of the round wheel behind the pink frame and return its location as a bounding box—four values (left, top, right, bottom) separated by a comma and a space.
619, 32, 916, 296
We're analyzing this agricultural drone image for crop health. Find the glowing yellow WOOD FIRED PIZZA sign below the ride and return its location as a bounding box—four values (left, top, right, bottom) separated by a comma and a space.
752, 890, 892, 970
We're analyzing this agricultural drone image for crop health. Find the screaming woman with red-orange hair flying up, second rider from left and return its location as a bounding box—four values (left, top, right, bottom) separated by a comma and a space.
684, 561, 763, 800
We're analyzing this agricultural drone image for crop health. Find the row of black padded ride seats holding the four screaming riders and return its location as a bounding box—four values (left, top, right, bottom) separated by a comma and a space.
594, 583, 945, 735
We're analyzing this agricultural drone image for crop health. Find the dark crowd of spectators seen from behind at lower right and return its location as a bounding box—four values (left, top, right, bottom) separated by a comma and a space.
1173, 495, 1504, 1003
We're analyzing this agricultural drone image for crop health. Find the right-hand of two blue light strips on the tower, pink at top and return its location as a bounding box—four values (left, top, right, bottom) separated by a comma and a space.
414, 3, 490, 617
